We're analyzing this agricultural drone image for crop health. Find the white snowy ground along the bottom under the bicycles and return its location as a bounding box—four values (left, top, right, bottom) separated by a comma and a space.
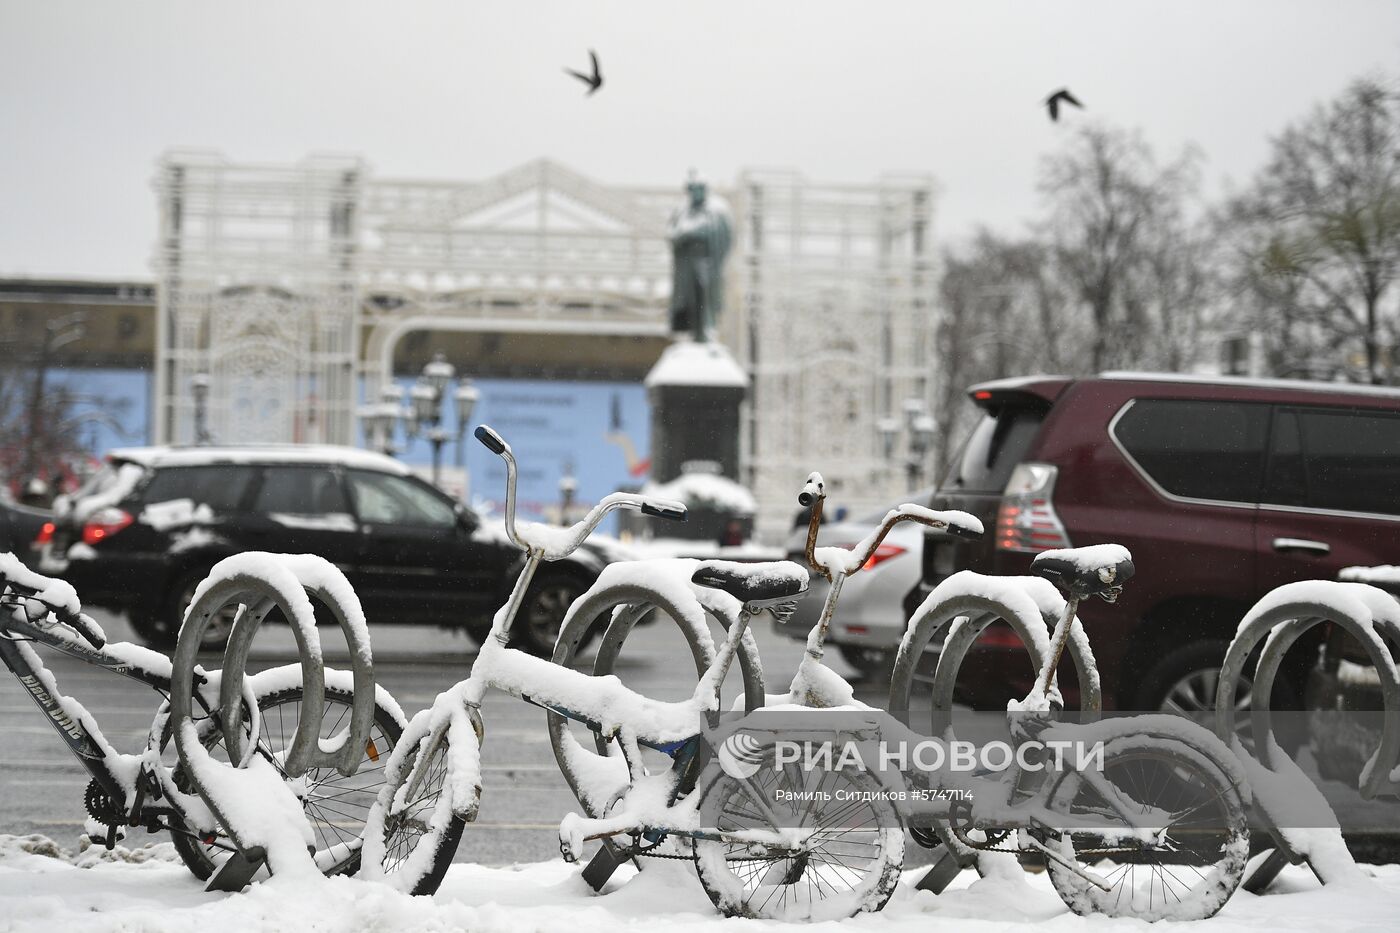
0, 836, 1400, 933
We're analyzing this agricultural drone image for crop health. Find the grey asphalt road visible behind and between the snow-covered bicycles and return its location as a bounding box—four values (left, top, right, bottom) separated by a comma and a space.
0, 612, 923, 866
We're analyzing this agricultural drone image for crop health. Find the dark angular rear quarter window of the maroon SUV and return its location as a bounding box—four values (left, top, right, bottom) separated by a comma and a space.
1113, 399, 1270, 503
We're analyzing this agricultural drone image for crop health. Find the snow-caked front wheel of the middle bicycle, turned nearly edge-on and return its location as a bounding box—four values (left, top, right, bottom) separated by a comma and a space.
364, 710, 466, 895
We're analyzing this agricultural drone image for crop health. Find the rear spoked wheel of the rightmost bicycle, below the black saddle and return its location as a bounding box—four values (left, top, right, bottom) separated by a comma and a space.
1029, 734, 1249, 920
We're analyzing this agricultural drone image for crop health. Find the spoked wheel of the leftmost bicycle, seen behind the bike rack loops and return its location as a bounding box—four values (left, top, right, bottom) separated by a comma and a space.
169, 685, 403, 881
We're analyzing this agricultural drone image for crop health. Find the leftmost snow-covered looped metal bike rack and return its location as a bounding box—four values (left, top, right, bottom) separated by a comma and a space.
169, 555, 375, 891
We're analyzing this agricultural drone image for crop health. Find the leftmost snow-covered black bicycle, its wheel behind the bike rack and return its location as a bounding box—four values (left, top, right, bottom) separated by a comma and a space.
0, 553, 405, 880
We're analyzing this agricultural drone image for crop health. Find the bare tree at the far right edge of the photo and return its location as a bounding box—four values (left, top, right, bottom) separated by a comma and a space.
1225, 78, 1400, 384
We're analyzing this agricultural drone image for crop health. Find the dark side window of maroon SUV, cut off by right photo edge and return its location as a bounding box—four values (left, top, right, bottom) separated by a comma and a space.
1266, 408, 1400, 516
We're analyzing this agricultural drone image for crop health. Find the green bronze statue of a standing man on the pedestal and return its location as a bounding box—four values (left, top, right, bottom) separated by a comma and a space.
669, 172, 729, 342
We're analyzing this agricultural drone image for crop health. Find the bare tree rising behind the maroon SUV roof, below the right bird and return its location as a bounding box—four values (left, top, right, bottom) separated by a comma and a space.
1039, 126, 1210, 371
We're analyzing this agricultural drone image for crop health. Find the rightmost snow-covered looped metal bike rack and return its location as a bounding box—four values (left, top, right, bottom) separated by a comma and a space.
1215, 580, 1400, 894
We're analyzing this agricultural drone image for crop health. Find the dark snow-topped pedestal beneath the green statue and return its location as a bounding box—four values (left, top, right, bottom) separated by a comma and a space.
644, 340, 749, 483
